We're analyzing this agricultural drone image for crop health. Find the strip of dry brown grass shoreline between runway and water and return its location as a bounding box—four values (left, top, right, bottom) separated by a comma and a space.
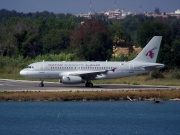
0, 90, 180, 102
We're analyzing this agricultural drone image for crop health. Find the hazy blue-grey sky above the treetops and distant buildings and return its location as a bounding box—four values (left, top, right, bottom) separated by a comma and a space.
0, 0, 180, 14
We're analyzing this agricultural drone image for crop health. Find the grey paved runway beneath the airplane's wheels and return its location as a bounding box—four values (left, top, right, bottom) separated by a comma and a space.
0, 79, 179, 92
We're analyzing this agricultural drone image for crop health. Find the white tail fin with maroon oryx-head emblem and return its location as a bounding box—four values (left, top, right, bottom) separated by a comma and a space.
132, 36, 162, 63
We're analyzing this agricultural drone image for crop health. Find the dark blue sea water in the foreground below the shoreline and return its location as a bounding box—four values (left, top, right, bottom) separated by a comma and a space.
0, 101, 180, 135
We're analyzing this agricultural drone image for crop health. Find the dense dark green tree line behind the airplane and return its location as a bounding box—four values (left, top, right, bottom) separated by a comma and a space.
0, 9, 180, 69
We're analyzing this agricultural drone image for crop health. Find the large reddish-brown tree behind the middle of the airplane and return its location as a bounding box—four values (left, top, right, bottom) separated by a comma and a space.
71, 19, 112, 60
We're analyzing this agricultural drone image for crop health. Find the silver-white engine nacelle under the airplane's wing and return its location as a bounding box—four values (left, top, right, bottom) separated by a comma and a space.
61, 76, 82, 84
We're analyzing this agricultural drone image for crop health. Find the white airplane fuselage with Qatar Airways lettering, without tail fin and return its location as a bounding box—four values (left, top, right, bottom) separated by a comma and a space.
20, 61, 164, 80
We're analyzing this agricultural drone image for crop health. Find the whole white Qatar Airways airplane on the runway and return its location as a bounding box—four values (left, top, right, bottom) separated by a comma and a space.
20, 36, 165, 87
